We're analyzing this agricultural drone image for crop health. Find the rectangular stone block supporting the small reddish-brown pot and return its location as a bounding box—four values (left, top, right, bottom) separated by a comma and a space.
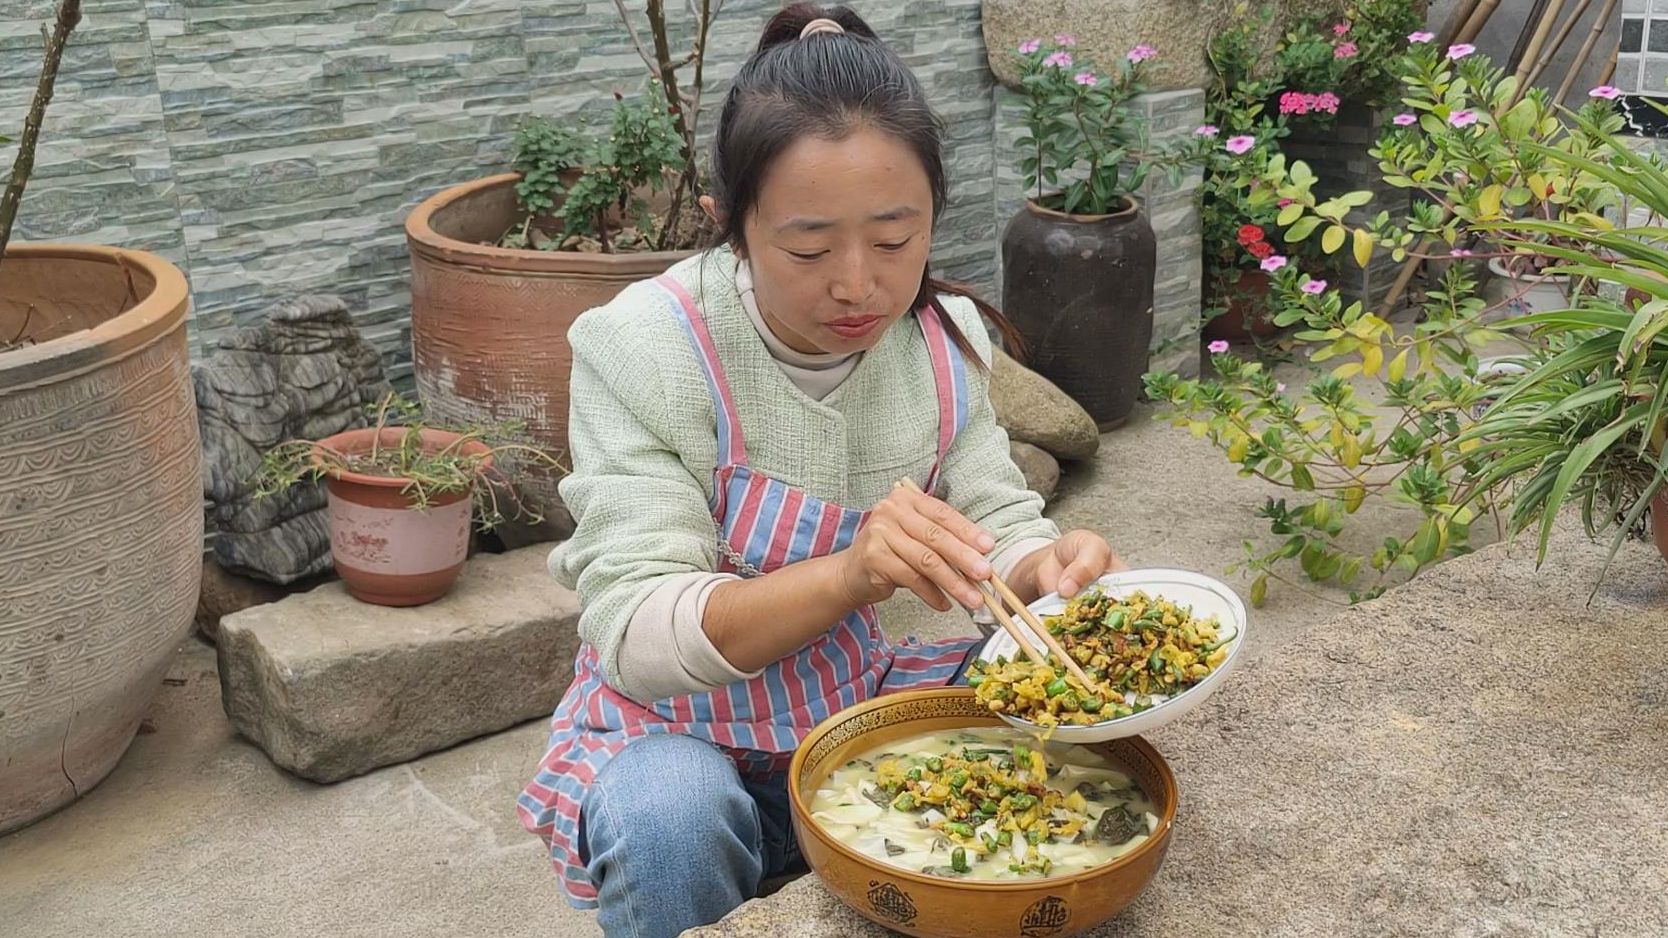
217, 544, 579, 781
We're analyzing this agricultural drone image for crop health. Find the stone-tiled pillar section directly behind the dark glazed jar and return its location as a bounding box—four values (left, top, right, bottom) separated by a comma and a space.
992, 87, 1204, 376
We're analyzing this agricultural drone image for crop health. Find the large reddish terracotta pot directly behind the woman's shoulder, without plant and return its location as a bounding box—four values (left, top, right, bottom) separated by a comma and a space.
405, 174, 692, 537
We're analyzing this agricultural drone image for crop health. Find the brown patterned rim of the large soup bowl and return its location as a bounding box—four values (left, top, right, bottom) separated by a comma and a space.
787, 688, 1181, 893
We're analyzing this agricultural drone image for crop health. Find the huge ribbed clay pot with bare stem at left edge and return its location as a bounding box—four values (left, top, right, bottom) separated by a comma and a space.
0, 0, 203, 833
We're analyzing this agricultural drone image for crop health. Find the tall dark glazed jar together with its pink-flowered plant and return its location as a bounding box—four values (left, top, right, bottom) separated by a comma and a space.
1002, 35, 1203, 431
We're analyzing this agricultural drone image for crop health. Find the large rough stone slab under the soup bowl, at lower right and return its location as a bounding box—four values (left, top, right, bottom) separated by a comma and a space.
686, 519, 1668, 938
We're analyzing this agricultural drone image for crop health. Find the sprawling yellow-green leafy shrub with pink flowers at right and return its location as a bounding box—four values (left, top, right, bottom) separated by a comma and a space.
1146, 40, 1621, 603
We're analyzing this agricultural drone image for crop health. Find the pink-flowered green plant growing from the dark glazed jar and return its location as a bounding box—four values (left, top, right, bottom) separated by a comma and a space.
1017, 33, 1209, 215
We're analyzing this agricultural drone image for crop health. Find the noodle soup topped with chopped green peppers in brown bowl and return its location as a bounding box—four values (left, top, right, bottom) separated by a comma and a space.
809, 728, 1159, 881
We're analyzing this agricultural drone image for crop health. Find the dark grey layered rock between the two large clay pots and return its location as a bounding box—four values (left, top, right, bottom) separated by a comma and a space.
192, 295, 392, 582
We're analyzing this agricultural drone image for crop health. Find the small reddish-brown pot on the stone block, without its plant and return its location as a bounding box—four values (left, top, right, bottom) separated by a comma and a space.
312, 427, 492, 606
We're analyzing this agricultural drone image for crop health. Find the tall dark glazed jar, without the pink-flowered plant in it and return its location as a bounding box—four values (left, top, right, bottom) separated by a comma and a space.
1002, 202, 1158, 431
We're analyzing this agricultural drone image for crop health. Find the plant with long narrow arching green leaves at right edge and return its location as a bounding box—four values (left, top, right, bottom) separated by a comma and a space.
1470, 129, 1668, 591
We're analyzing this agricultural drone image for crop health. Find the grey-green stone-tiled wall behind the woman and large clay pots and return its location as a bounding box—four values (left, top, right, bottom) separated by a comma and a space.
0, 0, 994, 382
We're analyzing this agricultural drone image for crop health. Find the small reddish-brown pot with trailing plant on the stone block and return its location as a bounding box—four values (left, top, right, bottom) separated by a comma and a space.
255, 396, 560, 606
